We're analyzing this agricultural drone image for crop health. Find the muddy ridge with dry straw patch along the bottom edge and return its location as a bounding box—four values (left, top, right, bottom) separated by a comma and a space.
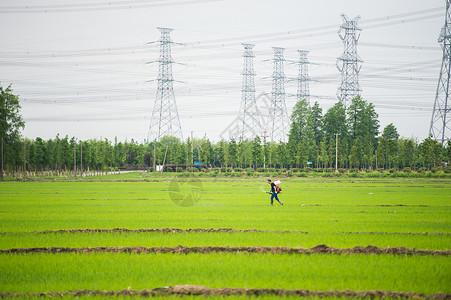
0, 285, 451, 299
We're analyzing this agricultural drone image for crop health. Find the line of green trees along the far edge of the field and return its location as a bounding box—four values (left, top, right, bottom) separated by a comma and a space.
0, 83, 451, 176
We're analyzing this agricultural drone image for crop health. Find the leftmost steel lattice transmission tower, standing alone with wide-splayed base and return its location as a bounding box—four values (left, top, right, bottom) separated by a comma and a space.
148, 27, 183, 141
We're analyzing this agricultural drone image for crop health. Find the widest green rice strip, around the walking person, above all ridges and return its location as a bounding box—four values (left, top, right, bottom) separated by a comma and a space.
0, 179, 451, 233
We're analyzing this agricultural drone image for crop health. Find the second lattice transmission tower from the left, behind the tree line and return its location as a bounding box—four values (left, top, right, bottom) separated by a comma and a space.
239, 44, 262, 139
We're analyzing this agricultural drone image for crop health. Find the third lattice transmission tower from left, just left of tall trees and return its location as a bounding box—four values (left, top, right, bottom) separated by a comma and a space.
268, 47, 290, 142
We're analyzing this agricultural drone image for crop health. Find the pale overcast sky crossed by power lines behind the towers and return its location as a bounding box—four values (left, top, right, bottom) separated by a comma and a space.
0, 0, 445, 141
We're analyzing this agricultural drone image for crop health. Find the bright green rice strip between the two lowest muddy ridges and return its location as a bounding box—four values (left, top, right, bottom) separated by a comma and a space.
0, 253, 451, 294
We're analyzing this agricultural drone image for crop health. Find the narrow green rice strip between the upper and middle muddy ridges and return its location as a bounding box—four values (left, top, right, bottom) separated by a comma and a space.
0, 232, 451, 250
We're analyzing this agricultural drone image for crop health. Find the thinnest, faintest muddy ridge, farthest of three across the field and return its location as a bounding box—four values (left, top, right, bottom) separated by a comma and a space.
0, 228, 451, 235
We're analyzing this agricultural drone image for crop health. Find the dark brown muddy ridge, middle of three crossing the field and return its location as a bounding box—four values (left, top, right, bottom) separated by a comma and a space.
0, 245, 451, 256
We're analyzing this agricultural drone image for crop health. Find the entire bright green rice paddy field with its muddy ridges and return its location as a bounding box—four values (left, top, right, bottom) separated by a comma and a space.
0, 172, 451, 299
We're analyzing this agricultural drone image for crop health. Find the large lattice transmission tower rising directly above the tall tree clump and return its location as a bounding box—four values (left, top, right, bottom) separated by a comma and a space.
337, 14, 363, 107
